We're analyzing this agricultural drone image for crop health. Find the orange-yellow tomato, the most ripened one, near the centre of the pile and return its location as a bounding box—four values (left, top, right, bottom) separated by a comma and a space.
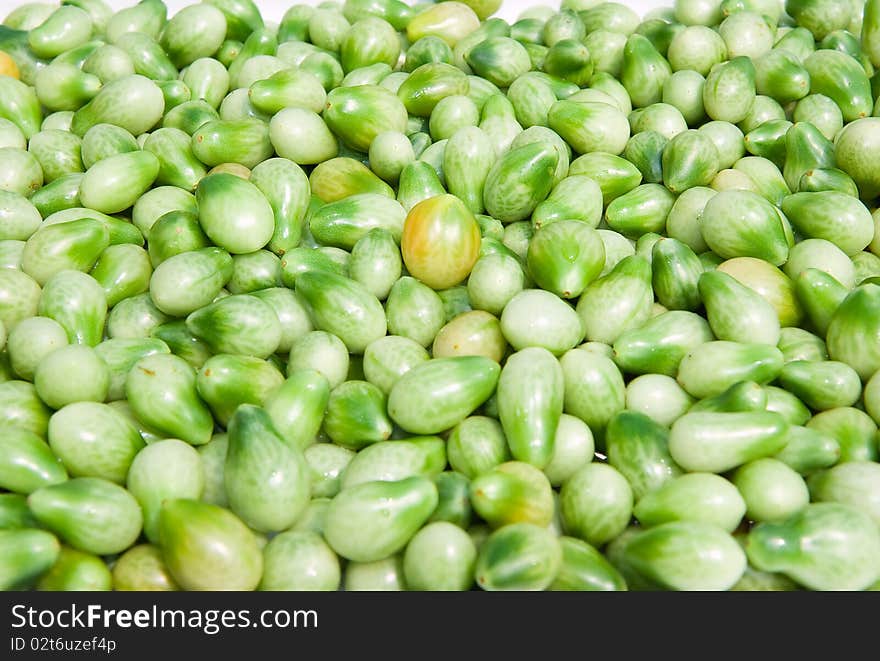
400, 195, 480, 289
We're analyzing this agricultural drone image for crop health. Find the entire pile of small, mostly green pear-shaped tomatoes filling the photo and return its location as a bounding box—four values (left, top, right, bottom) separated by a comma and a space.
0, 0, 880, 590
